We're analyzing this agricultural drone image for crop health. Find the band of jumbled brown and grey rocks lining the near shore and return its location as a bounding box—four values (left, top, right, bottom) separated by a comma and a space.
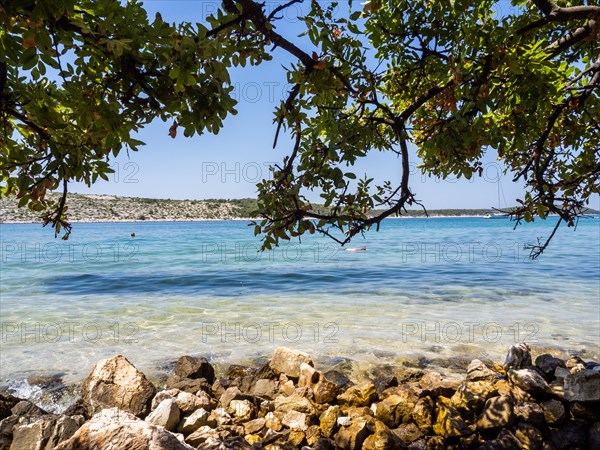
0, 344, 600, 450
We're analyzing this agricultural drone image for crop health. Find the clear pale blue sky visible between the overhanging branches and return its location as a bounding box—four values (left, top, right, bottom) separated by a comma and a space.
71, 0, 600, 209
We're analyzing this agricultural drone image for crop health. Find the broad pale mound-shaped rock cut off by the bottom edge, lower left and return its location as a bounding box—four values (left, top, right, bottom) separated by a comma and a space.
56, 408, 193, 450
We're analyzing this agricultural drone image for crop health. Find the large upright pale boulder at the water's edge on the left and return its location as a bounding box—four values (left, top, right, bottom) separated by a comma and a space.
81, 355, 156, 417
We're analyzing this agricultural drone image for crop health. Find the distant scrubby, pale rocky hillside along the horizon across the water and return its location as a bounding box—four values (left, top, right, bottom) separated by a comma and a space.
0, 194, 598, 222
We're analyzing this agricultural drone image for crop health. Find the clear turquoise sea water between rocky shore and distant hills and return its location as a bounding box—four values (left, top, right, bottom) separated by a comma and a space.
0, 218, 600, 386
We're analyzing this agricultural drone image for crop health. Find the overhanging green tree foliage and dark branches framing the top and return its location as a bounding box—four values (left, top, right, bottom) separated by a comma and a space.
0, 0, 600, 256
